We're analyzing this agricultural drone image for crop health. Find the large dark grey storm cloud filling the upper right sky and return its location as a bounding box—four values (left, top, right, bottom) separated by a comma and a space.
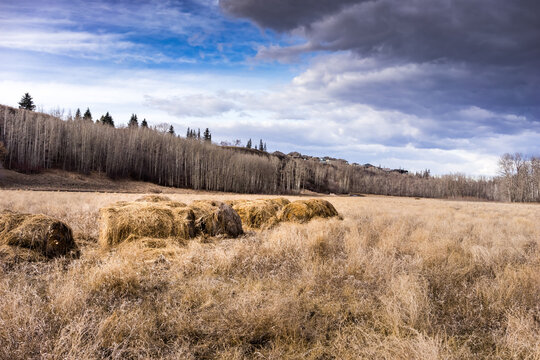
220, 0, 540, 138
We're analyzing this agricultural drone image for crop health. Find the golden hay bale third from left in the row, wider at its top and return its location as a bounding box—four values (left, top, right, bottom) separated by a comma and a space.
232, 198, 290, 229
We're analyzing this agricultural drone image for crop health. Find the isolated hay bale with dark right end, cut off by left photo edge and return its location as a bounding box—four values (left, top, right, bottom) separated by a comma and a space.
0, 211, 79, 258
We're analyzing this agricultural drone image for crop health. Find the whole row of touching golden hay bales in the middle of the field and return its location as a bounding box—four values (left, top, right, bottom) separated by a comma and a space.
99, 195, 338, 248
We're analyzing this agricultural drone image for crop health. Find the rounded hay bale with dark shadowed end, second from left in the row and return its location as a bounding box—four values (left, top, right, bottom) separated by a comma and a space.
189, 200, 244, 237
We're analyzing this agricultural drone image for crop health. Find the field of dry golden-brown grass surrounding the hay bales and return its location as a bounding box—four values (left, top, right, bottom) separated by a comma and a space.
0, 190, 540, 359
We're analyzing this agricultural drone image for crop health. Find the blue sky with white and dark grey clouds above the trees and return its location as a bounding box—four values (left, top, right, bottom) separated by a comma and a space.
0, 0, 540, 176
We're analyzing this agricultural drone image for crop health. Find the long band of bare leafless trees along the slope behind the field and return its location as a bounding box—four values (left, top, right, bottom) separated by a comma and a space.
0, 105, 540, 201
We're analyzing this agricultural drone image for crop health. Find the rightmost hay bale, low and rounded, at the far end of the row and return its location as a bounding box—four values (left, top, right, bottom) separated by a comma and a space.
278, 199, 338, 223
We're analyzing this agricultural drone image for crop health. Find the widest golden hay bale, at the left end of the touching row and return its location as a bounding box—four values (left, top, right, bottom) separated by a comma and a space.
99, 201, 195, 248
